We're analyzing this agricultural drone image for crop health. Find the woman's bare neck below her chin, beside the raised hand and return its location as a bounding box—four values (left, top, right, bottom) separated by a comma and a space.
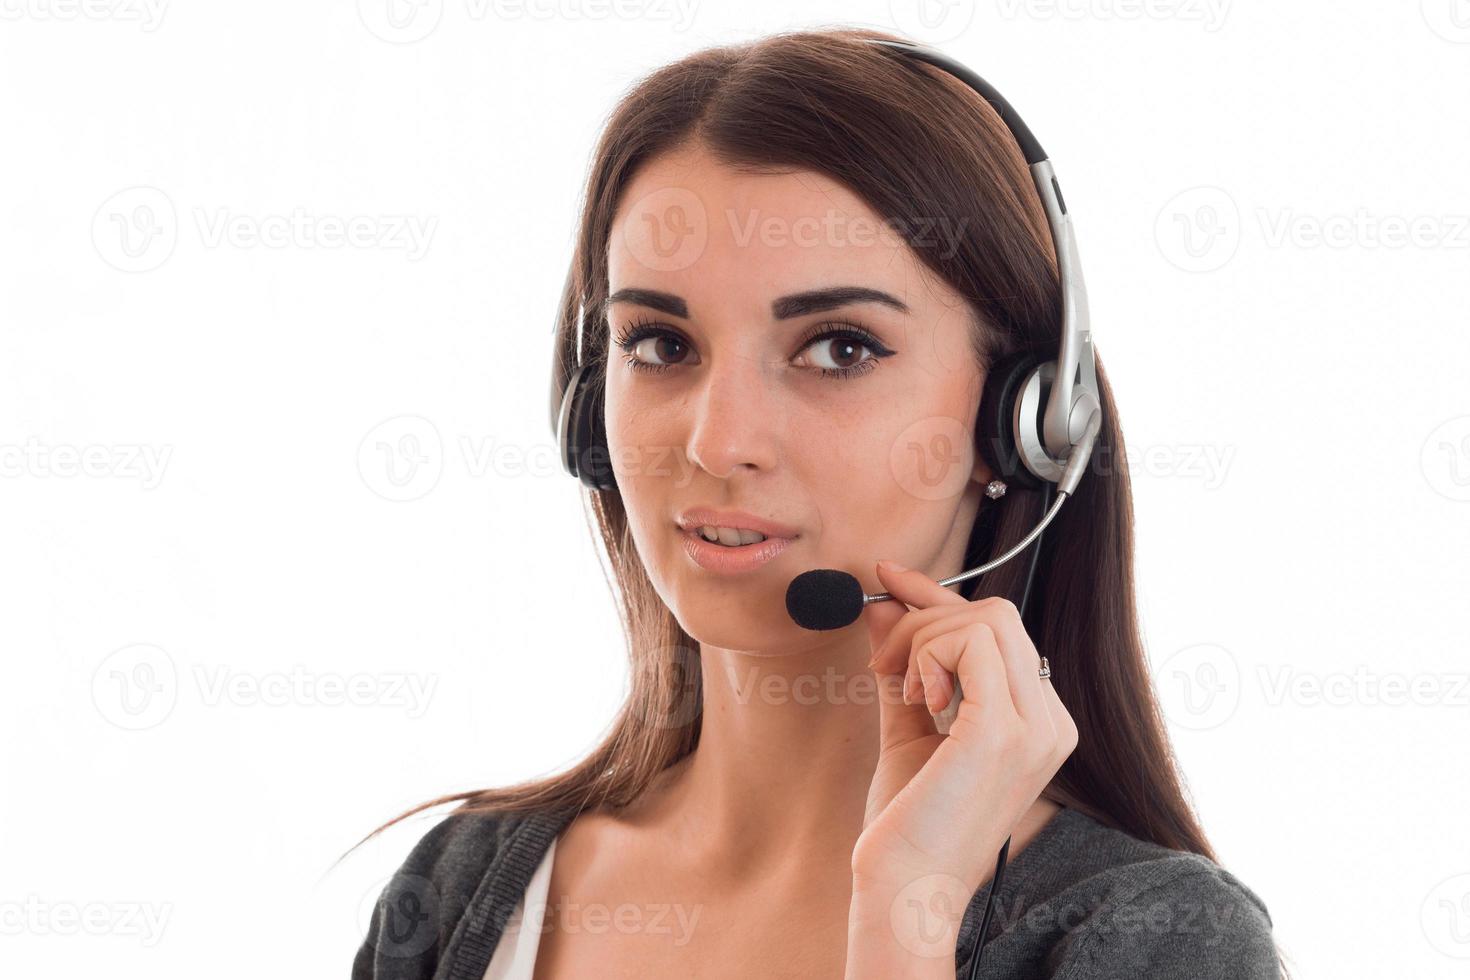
617, 630, 1058, 887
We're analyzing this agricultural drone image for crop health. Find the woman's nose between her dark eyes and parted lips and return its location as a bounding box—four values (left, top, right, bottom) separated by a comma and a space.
685, 354, 781, 479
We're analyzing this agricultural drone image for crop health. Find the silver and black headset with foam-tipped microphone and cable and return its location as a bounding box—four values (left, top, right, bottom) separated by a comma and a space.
550, 38, 1103, 980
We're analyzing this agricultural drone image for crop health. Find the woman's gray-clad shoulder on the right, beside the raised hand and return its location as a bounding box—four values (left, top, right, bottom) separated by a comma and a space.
1045, 814, 1280, 980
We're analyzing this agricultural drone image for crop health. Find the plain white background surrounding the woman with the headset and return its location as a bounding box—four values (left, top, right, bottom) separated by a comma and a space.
0, 0, 1470, 980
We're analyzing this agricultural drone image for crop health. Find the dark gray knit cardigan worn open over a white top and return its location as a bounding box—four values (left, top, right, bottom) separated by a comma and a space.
353, 808, 1280, 980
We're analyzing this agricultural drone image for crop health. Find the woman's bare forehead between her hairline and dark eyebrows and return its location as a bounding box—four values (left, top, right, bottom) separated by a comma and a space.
609, 144, 942, 316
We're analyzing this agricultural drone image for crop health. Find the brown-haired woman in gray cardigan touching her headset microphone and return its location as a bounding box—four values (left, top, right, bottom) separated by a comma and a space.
353, 31, 1279, 980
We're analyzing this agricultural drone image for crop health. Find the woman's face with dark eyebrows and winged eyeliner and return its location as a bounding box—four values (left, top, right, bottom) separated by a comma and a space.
606, 144, 989, 651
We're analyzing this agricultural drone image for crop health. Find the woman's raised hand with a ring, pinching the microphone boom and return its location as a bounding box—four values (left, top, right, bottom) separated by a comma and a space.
853, 564, 1078, 895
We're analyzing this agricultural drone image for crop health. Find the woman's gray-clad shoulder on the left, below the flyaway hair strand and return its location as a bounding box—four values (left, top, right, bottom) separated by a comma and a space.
351, 811, 567, 980
